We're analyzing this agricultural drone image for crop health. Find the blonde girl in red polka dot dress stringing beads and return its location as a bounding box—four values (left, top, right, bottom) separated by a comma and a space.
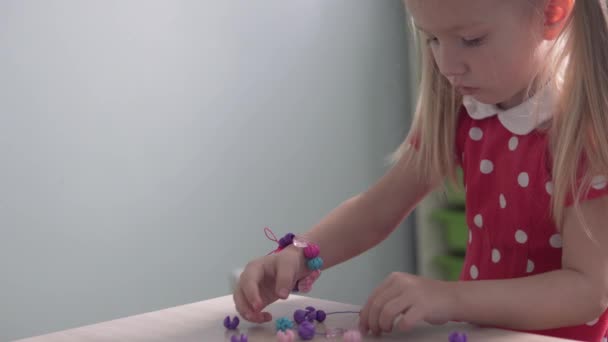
234, 0, 608, 341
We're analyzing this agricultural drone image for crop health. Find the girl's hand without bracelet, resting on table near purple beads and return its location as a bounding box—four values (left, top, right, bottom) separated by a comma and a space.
359, 272, 454, 334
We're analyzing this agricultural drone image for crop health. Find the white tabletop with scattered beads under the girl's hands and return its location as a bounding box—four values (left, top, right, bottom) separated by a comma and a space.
14, 295, 566, 342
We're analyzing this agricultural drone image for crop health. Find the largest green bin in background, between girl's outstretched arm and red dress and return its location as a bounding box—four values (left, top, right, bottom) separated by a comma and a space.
431, 209, 469, 254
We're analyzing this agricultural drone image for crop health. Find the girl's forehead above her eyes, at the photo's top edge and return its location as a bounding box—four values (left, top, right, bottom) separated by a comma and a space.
405, 0, 529, 32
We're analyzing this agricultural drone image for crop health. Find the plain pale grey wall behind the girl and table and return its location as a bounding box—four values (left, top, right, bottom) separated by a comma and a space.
0, 0, 413, 340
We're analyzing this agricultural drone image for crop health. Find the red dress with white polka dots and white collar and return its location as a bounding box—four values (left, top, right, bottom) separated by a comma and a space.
456, 89, 608, 342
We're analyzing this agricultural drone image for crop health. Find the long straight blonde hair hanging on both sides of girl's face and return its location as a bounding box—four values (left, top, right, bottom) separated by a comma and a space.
392, 0, 608, 233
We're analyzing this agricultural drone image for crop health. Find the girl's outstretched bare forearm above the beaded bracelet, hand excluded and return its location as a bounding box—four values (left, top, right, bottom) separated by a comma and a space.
304, 148, 438, 268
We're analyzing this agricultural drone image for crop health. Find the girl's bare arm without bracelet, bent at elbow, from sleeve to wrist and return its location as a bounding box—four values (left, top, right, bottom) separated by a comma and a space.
451, 197, 608, 330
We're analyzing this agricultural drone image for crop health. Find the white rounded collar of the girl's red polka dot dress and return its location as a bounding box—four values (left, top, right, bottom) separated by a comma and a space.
462, 86, 557, 135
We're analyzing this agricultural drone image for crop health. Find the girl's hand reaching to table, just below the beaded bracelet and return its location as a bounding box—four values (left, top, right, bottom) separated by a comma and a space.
233, 245, 307, 323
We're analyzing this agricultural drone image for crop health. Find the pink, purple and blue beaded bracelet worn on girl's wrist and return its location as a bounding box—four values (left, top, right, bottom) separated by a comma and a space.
264, 227, 323, 293
